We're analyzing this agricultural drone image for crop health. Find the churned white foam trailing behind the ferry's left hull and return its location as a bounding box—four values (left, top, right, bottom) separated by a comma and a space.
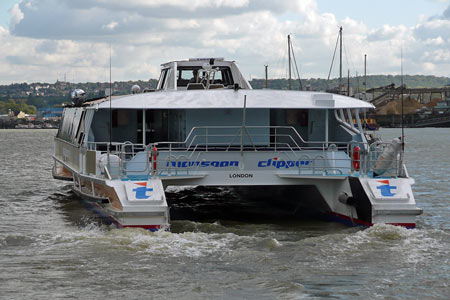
33, 223, 255, 257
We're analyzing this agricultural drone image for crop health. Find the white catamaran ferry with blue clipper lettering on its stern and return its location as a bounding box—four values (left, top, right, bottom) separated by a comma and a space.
53, 58, 422, 230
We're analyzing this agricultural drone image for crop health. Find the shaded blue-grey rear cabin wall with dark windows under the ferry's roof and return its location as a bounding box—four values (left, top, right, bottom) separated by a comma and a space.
91, 109, 308, 144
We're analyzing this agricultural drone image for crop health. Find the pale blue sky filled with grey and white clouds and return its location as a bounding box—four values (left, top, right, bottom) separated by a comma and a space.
0, 0, 450, 84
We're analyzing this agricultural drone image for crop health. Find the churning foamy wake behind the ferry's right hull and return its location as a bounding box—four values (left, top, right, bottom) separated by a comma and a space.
286, 224, 449, 270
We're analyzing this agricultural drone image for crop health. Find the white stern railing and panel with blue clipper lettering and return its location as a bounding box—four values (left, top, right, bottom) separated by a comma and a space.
78, 126, 403, 179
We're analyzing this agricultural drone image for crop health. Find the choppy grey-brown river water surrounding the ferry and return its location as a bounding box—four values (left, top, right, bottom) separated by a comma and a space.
0, 128, 450, 299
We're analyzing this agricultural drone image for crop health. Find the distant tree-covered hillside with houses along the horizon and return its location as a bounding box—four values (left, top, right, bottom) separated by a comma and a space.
0, 75, 450, 114
